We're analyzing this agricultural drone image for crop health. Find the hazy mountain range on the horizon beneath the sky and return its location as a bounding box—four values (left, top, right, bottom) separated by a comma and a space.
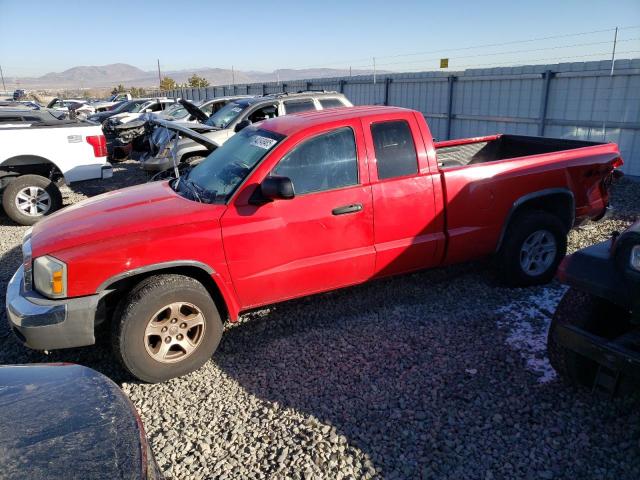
5, 63, 385, 89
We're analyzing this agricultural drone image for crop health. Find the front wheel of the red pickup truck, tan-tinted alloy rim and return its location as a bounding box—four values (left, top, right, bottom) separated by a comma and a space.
111, 274, 223, 383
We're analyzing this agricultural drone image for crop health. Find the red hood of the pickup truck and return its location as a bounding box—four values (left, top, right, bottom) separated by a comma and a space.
31, 182, 226, 258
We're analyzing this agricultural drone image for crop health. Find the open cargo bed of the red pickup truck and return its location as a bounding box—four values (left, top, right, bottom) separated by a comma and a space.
435, 135, 602, 169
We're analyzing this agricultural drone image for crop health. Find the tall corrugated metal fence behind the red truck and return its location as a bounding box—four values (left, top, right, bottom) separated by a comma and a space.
150, 59, 640, 175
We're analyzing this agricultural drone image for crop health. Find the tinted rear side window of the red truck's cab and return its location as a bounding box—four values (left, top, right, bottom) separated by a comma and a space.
371, 120, 418, 180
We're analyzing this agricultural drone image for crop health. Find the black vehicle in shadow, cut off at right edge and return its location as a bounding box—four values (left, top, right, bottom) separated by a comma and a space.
547, 221, 640, 396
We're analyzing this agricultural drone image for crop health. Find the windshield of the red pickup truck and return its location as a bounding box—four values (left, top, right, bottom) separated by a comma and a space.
174, 127, 284, 203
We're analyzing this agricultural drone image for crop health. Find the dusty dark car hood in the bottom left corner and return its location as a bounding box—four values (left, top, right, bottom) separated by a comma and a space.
0, 364, 163, 480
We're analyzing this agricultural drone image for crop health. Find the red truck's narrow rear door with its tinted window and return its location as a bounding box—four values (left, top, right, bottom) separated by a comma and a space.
363, 113, 444, 276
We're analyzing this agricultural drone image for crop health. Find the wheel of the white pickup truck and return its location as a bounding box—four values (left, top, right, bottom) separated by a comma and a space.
2, 175, 62, 225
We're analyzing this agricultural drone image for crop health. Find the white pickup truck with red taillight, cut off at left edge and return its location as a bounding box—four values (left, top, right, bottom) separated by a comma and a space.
0, 109, 113, 225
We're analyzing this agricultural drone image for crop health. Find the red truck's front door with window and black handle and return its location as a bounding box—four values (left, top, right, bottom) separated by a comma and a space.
222, 121, 375, 308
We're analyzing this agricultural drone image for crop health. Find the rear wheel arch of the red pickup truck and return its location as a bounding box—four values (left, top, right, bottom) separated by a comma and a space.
496, 188, 576, 252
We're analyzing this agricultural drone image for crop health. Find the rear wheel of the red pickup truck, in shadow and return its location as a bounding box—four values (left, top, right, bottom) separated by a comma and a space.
498, 210, 567, 287
